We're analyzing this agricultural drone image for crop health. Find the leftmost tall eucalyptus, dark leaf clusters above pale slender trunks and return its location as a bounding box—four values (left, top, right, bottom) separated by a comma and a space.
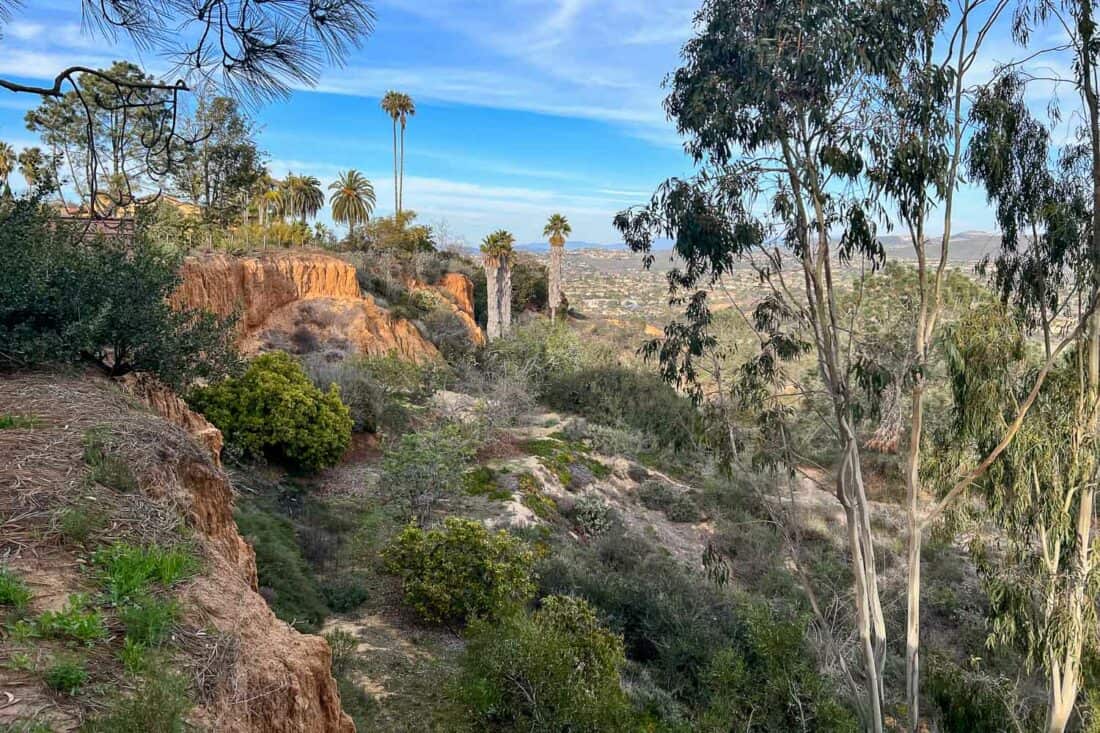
616, 0, 945, 731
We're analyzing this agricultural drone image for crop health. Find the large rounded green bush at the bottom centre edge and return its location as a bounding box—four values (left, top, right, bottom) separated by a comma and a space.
459, 597, 636, 733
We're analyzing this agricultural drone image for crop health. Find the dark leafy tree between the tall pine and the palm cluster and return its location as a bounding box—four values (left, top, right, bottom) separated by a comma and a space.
173, 95, 264, 227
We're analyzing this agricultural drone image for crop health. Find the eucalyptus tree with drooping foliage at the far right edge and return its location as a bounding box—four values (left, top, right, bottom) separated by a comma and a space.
952, 0, 1100, 717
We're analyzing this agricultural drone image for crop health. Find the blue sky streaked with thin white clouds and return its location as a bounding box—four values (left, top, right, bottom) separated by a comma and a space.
0, 0, 1073, 243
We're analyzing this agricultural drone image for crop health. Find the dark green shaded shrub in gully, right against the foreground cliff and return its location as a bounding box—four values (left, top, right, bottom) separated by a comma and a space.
234, 502, 328, 633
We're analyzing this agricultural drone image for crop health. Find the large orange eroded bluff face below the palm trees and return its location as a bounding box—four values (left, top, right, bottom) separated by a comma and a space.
172, 251, 439, 362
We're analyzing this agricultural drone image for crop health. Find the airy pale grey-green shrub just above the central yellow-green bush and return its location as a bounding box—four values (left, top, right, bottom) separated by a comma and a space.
382, 423, 475, 525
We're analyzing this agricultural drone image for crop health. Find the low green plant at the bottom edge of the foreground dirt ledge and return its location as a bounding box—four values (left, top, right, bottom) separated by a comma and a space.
80, 671, 191, 733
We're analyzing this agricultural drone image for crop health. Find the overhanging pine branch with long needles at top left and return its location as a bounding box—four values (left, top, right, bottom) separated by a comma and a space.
0, 0, 374, 216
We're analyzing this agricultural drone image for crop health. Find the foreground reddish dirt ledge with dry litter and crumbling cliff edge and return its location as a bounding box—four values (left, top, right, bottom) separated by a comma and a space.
0, 375, 355, 733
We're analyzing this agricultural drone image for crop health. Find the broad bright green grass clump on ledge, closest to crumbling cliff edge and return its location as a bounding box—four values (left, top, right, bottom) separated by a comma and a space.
91, 543, 199, 605
